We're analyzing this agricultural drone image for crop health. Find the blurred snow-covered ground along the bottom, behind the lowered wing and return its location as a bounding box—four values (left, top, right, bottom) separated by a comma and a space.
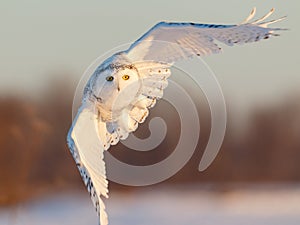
0, 186, 300, 225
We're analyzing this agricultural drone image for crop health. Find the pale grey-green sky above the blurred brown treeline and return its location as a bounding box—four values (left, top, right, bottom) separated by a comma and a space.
0, 0, 300, 113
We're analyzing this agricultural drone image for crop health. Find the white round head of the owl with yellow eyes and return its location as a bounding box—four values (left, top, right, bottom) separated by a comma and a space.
88, 61, 142, 119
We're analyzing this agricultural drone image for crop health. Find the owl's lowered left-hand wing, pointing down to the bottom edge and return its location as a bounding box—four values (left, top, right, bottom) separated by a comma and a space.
67, 101, 108, 225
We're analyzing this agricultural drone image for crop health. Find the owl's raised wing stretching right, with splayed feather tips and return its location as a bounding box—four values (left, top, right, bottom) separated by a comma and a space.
125, 8, 285, 63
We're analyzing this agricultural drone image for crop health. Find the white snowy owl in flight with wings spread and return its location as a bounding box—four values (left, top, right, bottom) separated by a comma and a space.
67, 8, 284, 225
